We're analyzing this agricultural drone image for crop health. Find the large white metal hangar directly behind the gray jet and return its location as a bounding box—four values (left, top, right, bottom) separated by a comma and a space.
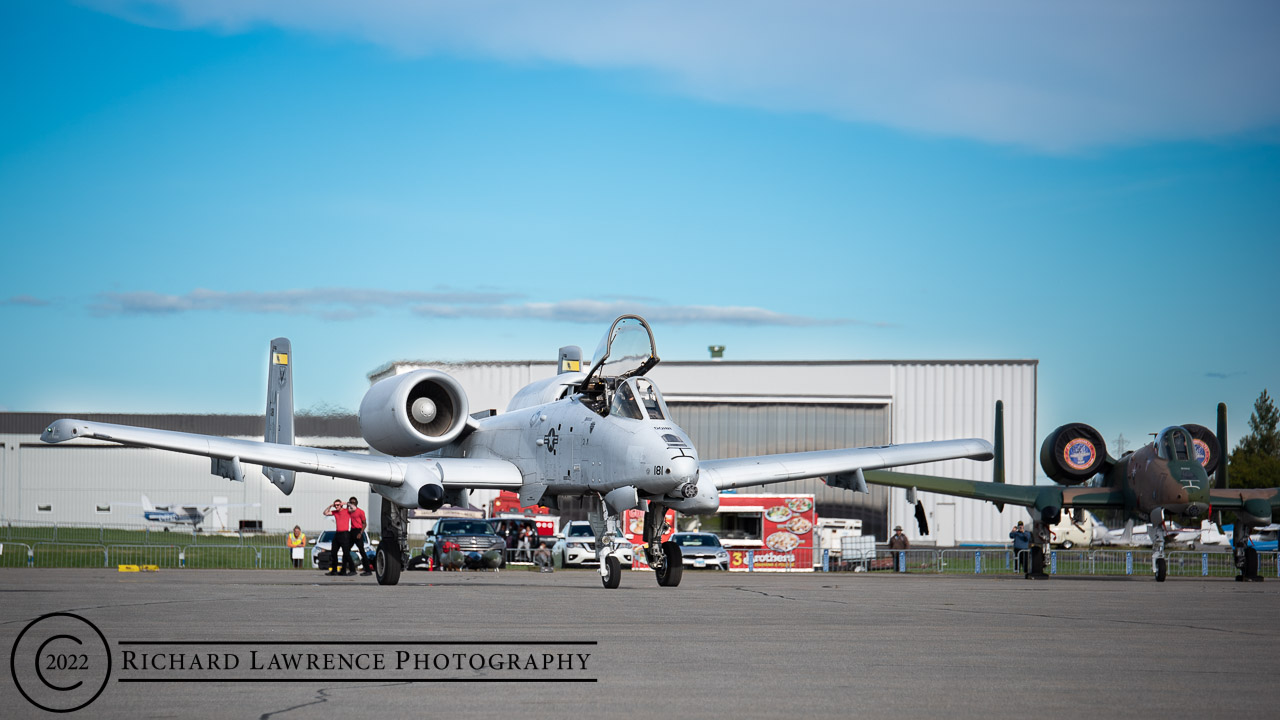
369, 360, 1038, 546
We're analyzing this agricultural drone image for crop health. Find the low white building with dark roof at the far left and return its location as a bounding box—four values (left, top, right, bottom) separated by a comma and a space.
0, 413, 370, 534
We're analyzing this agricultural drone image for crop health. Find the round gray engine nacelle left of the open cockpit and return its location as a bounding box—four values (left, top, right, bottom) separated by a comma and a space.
360, 370, 467, 457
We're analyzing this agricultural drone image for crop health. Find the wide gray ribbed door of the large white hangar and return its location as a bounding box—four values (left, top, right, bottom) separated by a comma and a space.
667, 397, 890, 536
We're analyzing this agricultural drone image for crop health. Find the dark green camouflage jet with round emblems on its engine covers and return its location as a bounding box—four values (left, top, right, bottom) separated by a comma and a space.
827, 402, 1280, 582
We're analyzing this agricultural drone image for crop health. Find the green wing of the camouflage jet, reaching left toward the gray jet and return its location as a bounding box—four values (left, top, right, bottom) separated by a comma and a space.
855, 470, 1124, 510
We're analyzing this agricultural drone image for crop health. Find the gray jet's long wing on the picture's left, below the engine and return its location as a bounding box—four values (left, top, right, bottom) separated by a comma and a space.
40, 419, 522, 489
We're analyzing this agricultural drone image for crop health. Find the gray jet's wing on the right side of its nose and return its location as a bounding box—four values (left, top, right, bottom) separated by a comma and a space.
699, 438, 992, 489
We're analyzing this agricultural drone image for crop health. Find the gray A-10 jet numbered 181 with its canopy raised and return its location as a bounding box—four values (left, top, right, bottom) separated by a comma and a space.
41, 315, 992, 588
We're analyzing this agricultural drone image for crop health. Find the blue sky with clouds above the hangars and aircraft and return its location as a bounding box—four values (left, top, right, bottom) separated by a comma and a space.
0, 0, 1280, 466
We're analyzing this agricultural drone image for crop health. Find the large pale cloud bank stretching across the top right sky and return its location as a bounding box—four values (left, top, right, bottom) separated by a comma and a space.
91, 0, 1280, 151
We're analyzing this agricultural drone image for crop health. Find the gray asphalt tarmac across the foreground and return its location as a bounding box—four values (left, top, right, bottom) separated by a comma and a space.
0, 569, 1280, 720
